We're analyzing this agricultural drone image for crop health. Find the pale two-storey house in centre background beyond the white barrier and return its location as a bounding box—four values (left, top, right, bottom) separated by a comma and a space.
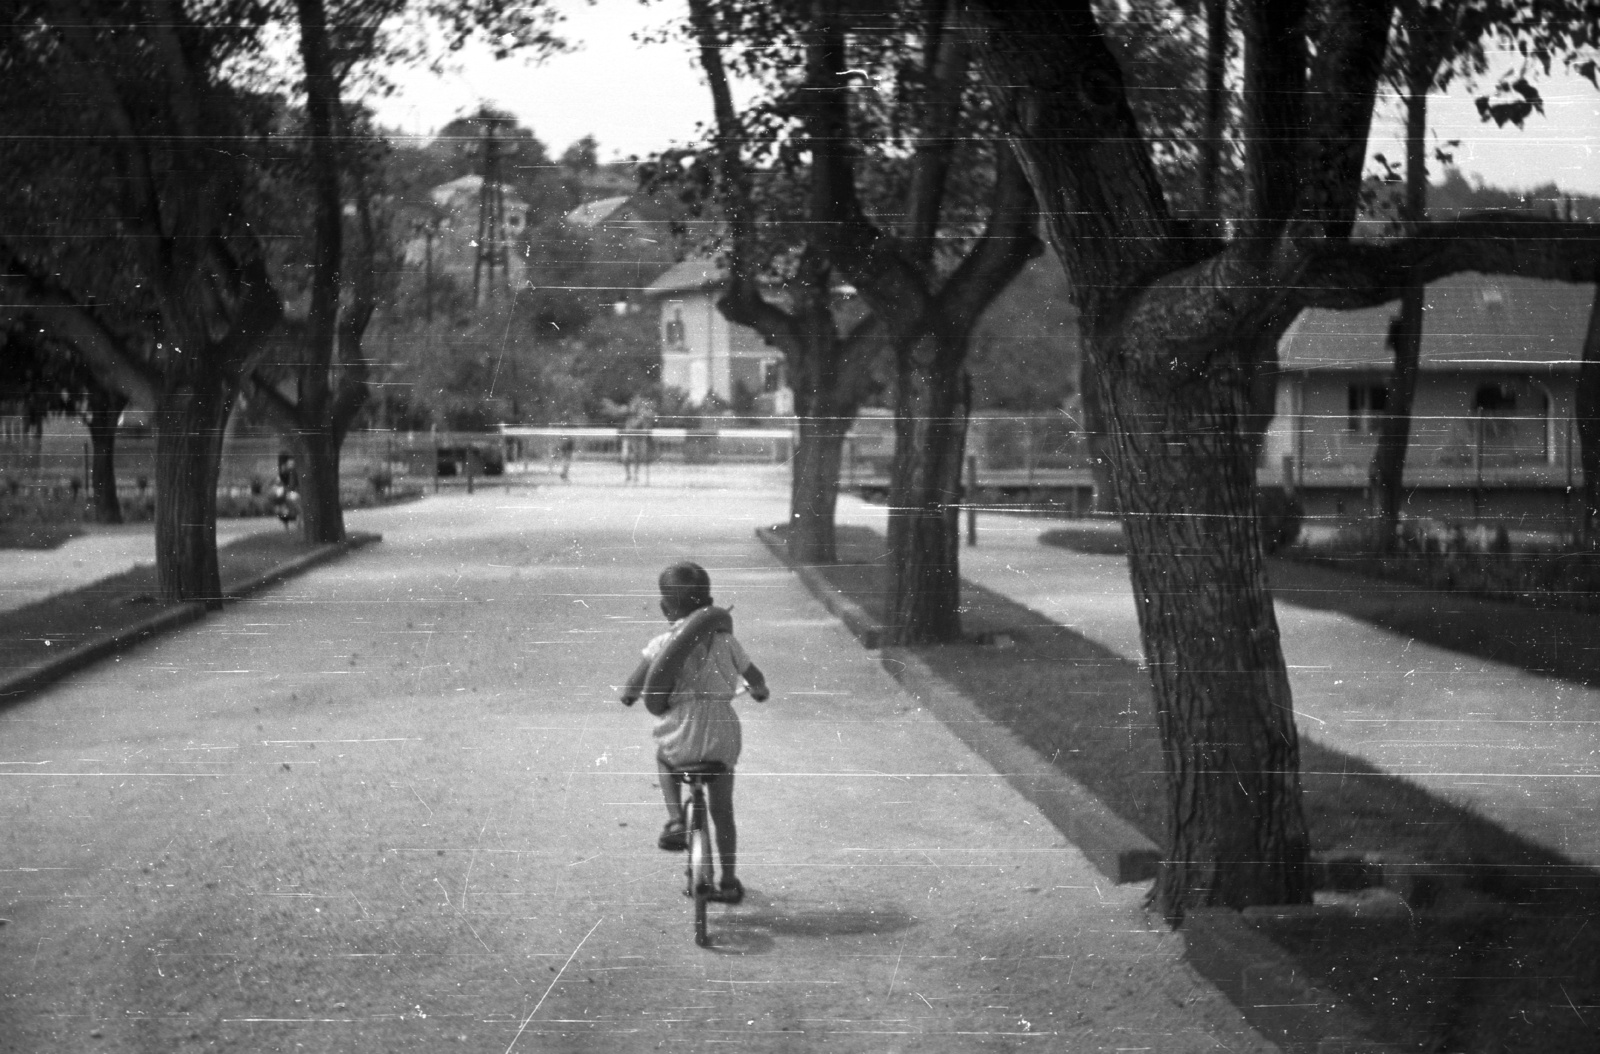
645, 256, 794, 416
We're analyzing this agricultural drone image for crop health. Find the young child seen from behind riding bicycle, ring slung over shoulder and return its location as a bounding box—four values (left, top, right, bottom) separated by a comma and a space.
622, 560, 770, 904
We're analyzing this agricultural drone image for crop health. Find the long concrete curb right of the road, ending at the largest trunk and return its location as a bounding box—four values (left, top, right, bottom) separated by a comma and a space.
755, 528, 1162, 883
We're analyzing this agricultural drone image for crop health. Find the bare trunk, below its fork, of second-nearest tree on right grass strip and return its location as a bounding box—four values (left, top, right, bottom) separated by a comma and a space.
883, 333, 971, 645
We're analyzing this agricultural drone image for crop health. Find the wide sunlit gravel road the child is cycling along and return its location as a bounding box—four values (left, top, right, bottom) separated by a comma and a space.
0, 479, 1270, 1052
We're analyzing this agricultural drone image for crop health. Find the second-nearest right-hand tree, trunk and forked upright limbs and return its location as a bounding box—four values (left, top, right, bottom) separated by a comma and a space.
806, 0, 1043, 645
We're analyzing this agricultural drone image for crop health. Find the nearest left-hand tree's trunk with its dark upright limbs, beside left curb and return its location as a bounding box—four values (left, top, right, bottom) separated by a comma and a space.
50, 0, 282, 605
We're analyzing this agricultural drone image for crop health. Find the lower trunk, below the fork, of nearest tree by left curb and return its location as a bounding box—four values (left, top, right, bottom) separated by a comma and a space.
155, 380, 234, 608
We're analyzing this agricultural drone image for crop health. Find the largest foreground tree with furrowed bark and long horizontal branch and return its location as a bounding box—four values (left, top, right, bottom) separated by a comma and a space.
968, 0, 1597, 921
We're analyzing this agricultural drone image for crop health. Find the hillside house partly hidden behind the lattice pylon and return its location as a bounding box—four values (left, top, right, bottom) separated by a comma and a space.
405, 174, 528, 296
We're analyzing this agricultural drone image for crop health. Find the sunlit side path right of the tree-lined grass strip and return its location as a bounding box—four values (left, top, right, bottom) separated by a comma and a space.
838, 499, 1600, 867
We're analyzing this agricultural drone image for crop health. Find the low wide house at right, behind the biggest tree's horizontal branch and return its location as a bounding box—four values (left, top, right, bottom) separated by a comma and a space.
1261, 273, 1595, 523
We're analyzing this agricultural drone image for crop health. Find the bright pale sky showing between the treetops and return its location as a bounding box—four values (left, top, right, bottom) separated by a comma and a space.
378, 0, 1600, 195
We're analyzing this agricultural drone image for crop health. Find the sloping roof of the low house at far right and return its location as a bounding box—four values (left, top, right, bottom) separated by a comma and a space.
1278, 272, 1595, 373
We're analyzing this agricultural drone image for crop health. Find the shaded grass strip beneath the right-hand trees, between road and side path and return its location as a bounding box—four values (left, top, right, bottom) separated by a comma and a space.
816, 526, 1600, 1054
